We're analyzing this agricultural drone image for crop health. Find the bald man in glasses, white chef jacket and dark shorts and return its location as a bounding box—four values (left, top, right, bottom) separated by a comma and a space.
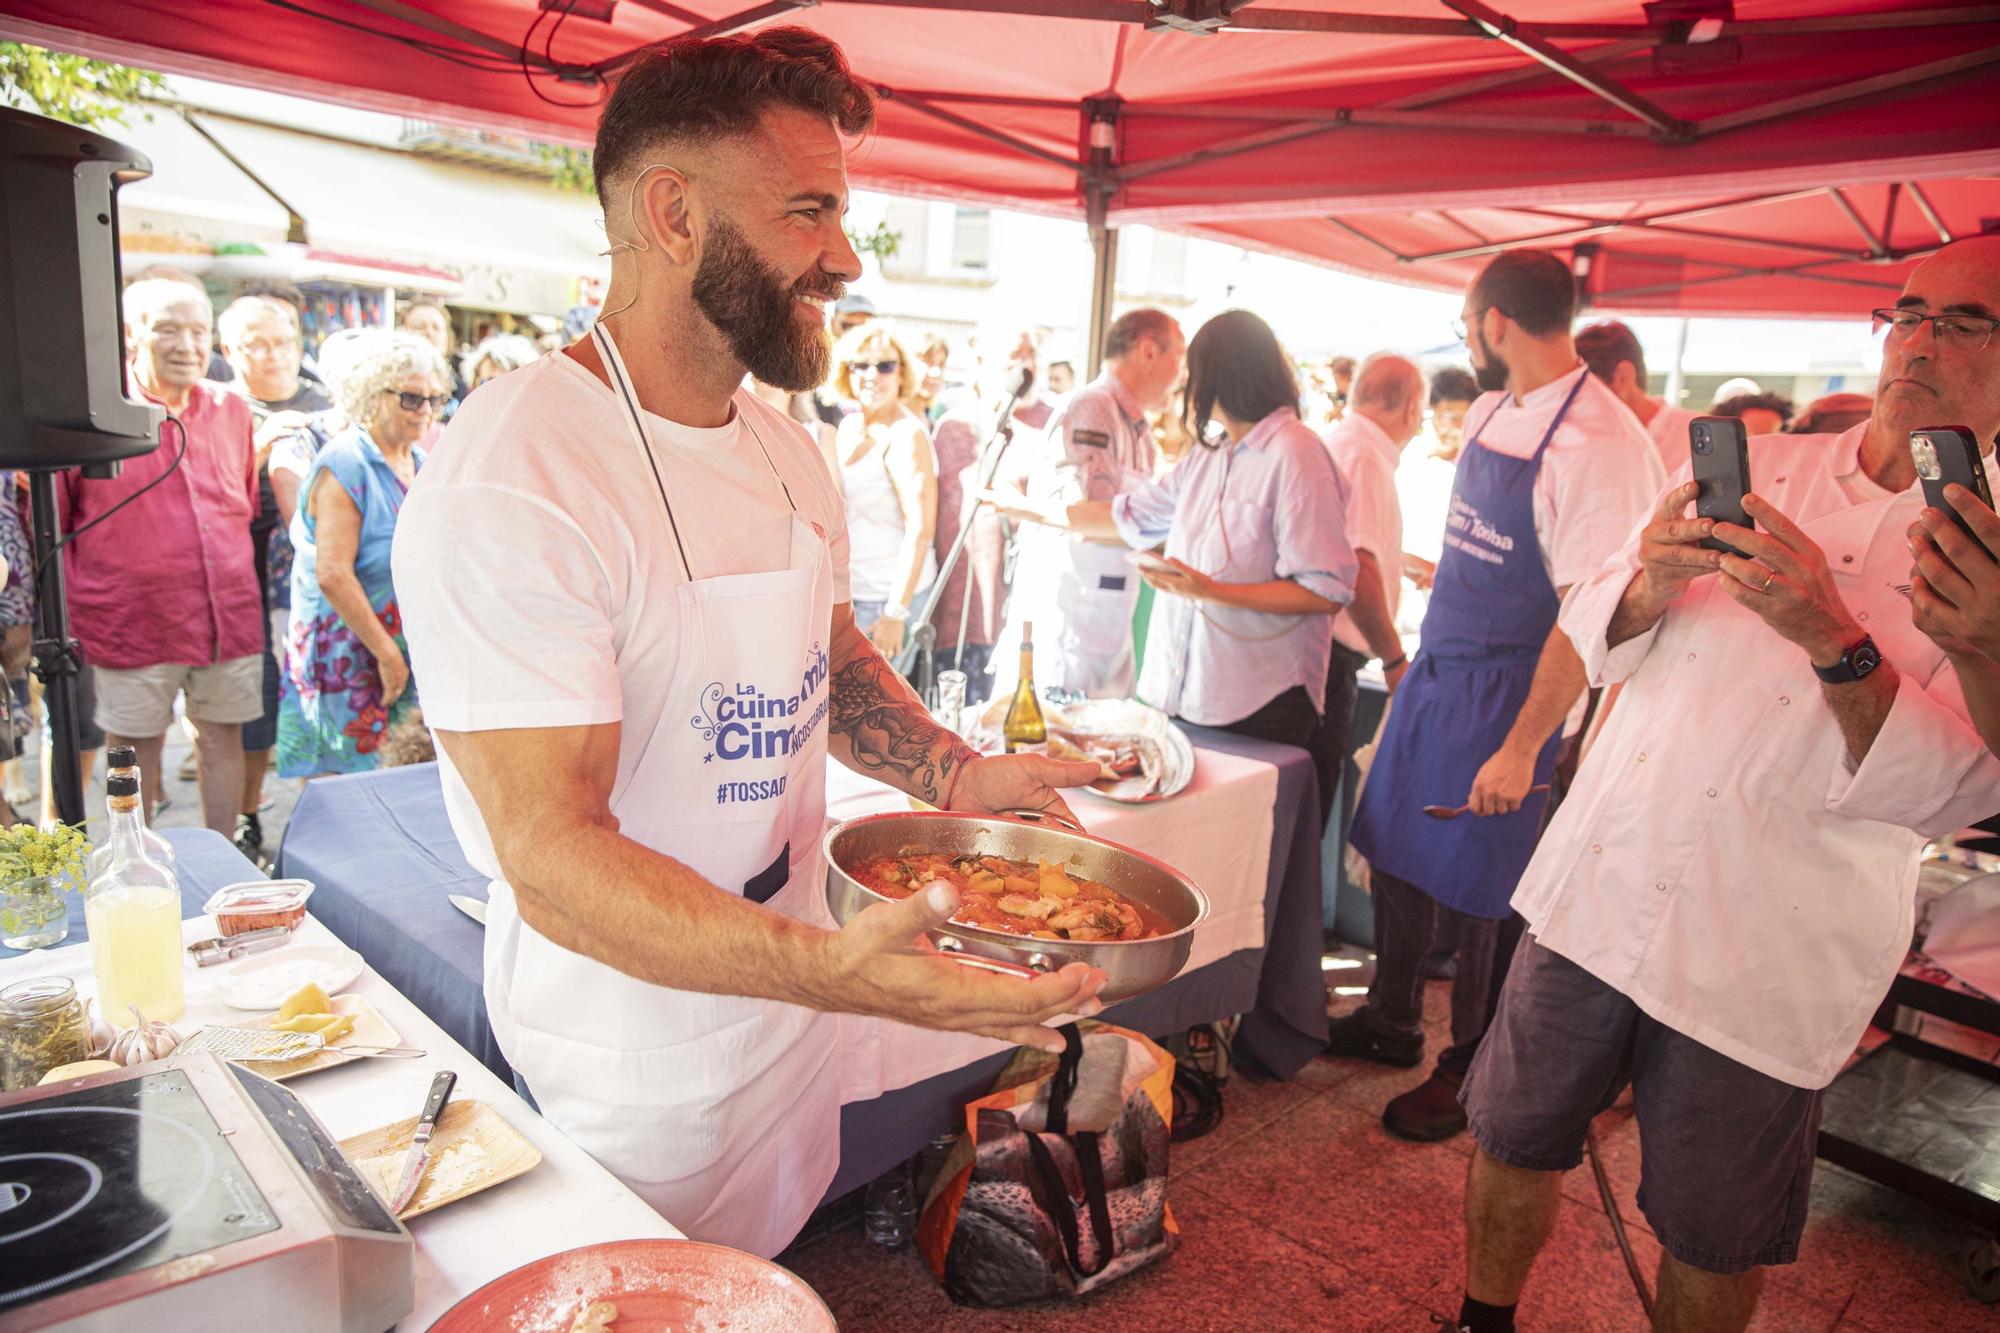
1458, 236, 2000, 1333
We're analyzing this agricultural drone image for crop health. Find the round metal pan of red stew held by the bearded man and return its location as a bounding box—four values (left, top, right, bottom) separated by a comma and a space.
822, 811, 1208, 1003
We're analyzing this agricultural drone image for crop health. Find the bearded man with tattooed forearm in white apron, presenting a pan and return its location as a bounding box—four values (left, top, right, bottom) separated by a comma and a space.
396, 28, 1104, 1255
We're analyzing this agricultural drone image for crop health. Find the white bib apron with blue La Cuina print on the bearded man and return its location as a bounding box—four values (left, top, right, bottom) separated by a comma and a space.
486, 324, 840, 1257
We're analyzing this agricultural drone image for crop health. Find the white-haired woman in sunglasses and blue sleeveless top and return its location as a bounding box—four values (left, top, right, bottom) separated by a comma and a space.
278, 334, 450, 777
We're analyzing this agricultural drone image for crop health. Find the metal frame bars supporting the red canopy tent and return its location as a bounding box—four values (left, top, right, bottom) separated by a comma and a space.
191, 0, 2000, 348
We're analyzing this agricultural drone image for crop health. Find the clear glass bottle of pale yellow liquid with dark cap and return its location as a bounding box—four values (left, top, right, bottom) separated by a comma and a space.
84, 775, 186, 1027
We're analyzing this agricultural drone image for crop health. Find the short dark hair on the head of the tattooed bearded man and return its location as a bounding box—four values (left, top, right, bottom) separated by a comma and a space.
590, 24, 874, 202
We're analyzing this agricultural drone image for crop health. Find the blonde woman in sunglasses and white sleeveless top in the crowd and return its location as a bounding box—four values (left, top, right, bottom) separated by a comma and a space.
834, 320, 938, 656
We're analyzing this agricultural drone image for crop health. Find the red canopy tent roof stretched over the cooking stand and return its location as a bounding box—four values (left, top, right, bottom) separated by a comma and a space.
0, 0, 2000, 342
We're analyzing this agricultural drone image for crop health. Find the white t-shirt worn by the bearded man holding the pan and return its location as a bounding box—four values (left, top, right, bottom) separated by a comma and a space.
394, 352, 848, 879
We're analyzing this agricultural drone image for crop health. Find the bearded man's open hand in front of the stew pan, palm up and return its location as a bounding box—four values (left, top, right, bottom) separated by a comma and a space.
828, 880, 1106, 1053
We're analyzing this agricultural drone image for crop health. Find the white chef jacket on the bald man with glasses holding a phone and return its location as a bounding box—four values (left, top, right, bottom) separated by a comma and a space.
1514, 424, 2000, 1089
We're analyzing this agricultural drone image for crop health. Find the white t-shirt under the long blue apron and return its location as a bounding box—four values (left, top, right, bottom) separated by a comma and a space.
1466, 366, 1666, 590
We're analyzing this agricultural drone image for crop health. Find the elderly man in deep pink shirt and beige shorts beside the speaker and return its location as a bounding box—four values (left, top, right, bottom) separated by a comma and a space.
62, 278, 264, 837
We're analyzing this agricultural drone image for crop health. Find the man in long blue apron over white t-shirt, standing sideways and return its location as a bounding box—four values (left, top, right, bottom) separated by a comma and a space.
1328, 252, 1664, 1139
